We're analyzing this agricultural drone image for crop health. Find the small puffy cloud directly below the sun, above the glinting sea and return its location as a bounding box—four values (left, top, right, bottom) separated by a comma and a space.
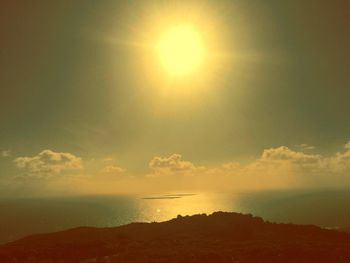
149, 154, 196, 173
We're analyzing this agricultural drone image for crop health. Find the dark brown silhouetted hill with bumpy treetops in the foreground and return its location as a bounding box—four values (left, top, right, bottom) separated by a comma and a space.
0, 212, 350, 263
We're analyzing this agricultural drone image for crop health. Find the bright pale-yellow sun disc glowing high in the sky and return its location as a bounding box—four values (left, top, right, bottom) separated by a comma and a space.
156, 26, 205, 76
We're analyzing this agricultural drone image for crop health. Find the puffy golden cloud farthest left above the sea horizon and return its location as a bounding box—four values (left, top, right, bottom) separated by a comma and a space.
14, 150, 83, 177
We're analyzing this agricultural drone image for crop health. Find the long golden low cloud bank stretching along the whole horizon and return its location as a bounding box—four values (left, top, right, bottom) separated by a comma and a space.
7, 141, 350, 197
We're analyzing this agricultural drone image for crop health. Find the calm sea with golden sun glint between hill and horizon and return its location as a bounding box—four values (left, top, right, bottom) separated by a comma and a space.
0, 191, 350, 243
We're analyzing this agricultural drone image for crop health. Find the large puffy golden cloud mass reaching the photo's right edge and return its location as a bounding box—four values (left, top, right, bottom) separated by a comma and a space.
235, 141, 350, 187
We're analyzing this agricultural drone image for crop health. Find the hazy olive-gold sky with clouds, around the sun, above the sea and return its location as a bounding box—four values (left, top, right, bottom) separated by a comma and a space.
0, 0, 350, 196
